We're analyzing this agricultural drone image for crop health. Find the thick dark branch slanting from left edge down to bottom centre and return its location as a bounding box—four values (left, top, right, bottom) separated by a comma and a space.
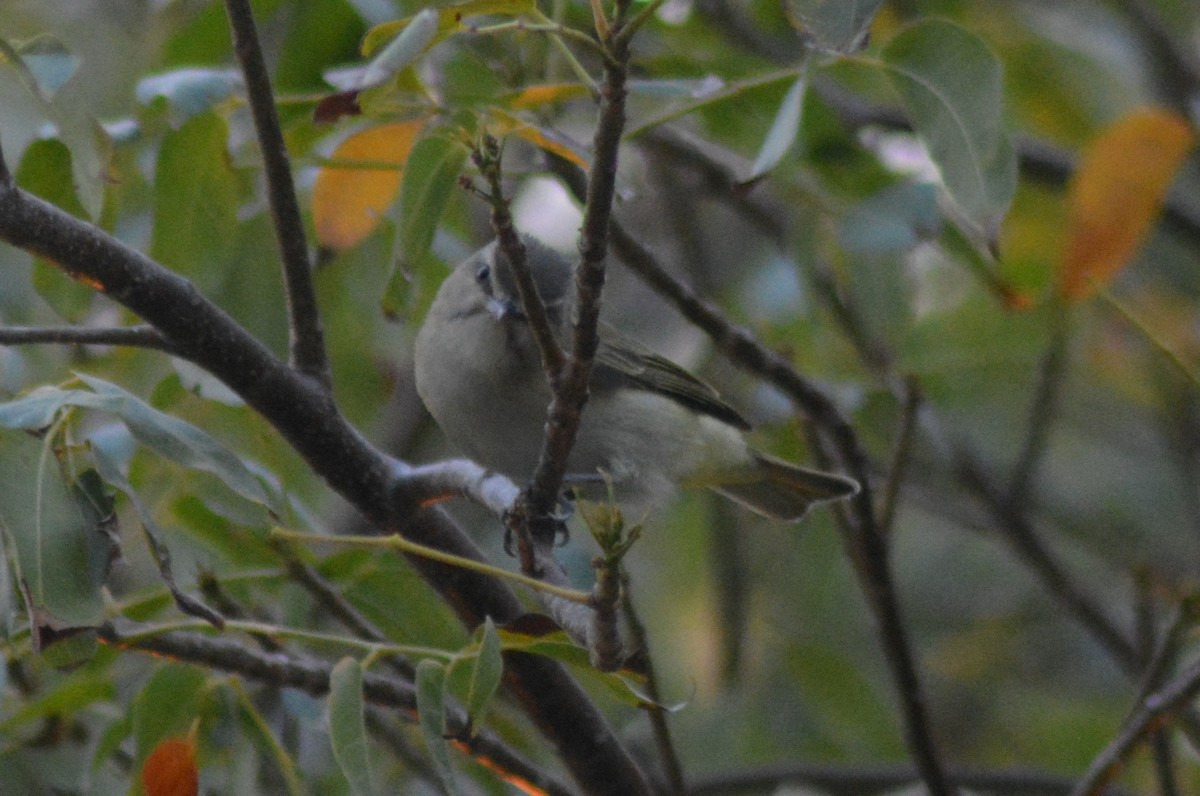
0, 158, 647, 795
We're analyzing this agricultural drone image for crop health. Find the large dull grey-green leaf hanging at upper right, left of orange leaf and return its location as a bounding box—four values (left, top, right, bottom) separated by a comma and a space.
883, 19, 1016, 237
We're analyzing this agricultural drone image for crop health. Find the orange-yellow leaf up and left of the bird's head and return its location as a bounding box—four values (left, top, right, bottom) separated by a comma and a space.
312, 119, 425, 250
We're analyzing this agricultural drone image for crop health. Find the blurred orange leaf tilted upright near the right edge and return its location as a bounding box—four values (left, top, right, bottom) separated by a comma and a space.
1058, 109, 1195, 300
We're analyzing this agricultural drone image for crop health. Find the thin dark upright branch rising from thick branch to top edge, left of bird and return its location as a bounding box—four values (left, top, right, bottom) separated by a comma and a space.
226, 0, 330, 388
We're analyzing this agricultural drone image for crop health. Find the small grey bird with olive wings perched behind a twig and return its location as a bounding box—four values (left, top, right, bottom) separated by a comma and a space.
415, 235, 858, 520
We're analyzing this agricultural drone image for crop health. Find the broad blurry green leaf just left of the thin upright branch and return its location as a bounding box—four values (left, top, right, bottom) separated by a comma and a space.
150, 113, 239, 291
